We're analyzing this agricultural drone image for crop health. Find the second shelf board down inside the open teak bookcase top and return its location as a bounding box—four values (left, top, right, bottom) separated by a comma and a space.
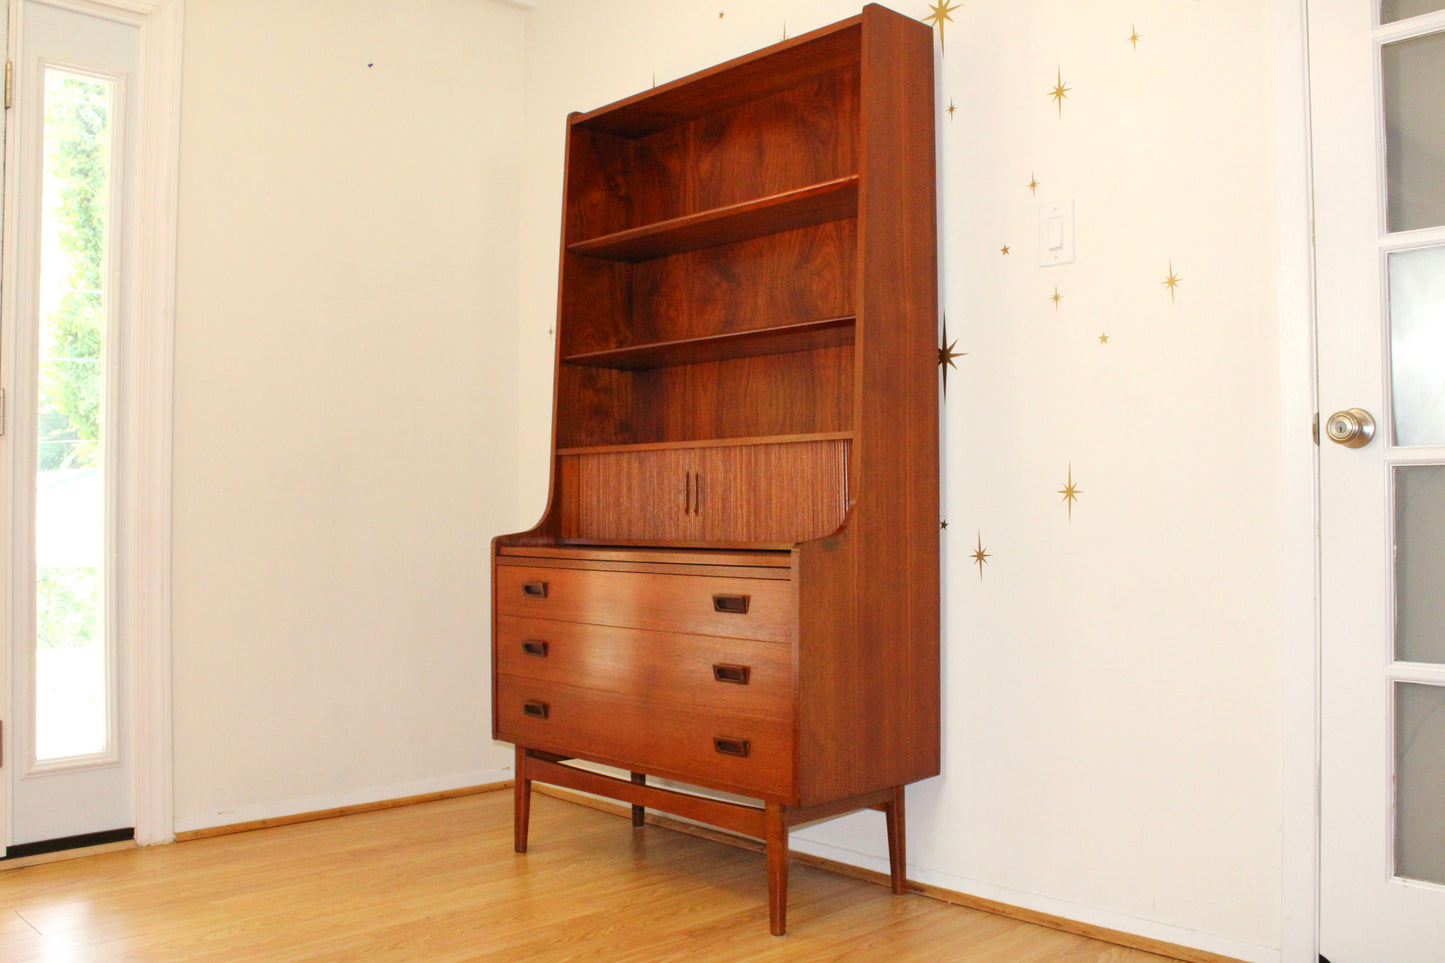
562, 317, 855, 370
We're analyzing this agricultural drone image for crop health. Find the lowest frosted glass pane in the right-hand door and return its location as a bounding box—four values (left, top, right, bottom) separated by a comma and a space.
1394, 682, 1445, 883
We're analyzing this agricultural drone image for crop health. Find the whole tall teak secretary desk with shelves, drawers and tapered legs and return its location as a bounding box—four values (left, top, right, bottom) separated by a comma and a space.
493, 6, 939, 936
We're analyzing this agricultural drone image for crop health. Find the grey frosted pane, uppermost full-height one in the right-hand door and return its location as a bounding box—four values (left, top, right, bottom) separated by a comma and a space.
1380, 33, 1445, 231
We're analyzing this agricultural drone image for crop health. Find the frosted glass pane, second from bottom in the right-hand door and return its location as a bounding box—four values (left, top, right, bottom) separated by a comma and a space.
1394, 464, 1445, 662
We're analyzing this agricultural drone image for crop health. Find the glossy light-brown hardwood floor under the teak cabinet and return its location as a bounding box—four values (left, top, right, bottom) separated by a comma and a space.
0, 792, 1166, 963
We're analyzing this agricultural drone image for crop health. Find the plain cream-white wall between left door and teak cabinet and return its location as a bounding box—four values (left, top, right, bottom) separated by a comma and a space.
173, 0, 526, 830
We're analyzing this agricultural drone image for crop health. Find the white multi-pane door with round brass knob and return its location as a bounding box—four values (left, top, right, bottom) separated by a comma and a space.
1309, 0, 1445, 963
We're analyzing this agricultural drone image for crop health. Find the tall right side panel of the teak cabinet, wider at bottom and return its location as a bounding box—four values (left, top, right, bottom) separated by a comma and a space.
799, 6, 939, 803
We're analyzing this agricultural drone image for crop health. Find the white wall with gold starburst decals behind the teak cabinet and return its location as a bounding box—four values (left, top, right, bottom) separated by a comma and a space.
516, 0, 1283, 960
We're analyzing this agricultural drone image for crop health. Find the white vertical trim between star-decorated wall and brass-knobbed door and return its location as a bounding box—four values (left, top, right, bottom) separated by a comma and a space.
1269, 0, 1319, 963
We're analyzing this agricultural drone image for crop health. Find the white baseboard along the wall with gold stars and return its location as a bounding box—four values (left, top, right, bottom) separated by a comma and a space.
789, 834, 1280, 963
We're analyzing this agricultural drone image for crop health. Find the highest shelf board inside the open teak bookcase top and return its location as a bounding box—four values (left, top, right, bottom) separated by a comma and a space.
566, 174, 858, 262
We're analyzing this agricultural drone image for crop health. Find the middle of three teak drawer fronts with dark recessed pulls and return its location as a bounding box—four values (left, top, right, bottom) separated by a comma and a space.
497, 616, 792, 719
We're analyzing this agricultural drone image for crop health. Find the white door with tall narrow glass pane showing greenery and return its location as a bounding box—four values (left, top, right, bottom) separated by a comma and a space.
3, 0, 140, 855
